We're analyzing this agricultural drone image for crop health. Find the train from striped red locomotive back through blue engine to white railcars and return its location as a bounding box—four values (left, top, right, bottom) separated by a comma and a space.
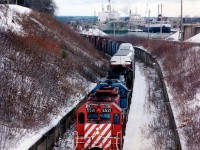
74, 43, 135, 150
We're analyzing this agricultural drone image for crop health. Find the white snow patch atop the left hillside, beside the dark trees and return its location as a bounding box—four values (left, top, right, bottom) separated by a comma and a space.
0, 4, 31, 33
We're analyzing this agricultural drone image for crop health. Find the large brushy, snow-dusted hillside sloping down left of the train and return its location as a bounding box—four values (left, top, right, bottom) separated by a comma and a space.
0, 5, 108, 150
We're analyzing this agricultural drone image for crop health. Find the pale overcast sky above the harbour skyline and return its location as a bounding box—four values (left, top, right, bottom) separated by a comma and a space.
54, 0, 200, 17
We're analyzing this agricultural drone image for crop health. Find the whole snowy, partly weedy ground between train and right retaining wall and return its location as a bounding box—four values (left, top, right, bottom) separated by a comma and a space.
123, 63, 176, 150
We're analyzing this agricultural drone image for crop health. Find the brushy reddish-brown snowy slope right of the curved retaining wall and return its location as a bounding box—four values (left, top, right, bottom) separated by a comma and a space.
150, 42, 200, 150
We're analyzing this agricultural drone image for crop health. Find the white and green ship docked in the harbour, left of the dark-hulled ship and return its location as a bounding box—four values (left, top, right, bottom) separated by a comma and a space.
98, 0, 128, 34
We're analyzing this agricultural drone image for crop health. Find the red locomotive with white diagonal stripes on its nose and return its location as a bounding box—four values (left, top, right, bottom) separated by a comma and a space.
74, 87, 123, 150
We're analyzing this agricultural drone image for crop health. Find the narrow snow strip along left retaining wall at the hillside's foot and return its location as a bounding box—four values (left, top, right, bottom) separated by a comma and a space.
12, 83, 96, 150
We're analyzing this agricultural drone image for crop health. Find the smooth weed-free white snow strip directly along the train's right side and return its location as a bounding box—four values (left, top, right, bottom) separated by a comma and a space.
123, 63, 153, 150
